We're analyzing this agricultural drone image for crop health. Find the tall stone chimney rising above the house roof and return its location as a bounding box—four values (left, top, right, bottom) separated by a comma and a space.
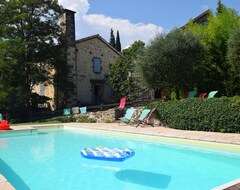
60, 9, 76, 45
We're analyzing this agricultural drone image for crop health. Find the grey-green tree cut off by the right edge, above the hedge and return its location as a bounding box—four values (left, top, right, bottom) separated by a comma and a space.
227, 25, 240, 96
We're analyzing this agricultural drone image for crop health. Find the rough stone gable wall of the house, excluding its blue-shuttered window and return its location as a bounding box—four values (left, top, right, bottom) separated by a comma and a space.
76, 35, 120, 105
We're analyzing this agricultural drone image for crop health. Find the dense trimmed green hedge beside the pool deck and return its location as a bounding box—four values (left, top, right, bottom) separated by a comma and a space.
151, 96, 240, 133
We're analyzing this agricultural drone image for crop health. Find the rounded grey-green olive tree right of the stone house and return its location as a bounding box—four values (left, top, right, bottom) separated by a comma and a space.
138, 29, 203, 99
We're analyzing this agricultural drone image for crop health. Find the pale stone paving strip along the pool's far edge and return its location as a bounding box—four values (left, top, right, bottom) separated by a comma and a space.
0, 123, 240, 145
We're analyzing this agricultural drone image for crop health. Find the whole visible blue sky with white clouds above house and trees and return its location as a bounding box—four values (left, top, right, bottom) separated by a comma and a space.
59, 0, 240, 48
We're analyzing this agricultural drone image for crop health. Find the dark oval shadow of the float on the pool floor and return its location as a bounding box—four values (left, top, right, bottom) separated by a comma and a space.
115, 170, 171, 189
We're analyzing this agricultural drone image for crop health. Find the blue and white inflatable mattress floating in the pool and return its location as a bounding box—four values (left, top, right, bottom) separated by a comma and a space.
81, 146, 134, 162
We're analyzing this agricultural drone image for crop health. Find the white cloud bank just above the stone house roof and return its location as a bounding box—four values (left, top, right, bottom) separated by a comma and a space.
59, 0, 164, 48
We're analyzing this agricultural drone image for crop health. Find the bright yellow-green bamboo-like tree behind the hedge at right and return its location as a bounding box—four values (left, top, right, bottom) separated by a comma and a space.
186, 5, 238, 94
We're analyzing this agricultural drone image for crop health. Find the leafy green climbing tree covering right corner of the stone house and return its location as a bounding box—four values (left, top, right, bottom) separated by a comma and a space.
109, 41, 145, 100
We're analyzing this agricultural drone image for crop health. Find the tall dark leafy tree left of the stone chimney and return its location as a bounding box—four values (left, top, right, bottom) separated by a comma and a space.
0, 0, 63, 119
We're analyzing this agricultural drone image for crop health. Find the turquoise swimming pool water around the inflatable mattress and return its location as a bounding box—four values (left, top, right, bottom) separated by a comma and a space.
0, 129, 240, 190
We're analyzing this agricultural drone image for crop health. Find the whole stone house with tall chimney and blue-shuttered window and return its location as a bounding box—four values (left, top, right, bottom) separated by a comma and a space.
34, 9, 121, 110
